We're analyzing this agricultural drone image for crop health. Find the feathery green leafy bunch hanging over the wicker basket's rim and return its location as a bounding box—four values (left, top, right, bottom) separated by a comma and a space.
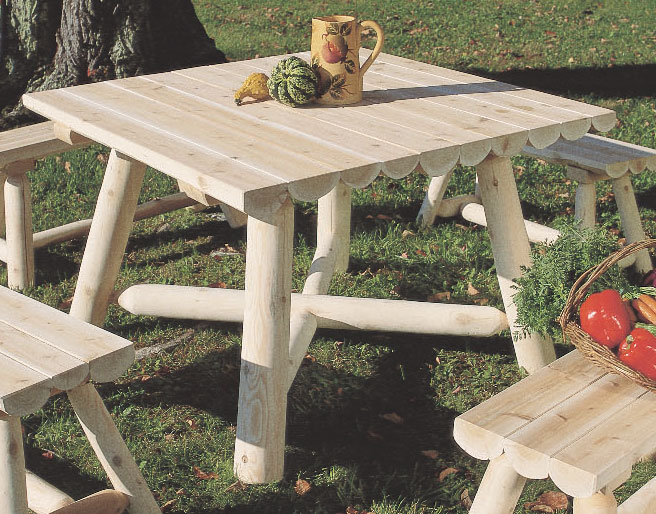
513, 224, 632, 340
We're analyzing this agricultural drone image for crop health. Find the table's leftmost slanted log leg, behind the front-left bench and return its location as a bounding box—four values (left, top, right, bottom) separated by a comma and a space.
71, 150, 146, 326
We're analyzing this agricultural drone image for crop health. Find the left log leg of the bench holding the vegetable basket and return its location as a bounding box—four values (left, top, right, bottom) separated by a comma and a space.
469, 453, 526, 514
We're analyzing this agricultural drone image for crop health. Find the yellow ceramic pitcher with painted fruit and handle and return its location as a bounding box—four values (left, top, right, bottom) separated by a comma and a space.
311, 16, 385, 105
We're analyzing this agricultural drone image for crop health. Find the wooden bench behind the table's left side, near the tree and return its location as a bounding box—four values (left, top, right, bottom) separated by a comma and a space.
0, 121, 240, 289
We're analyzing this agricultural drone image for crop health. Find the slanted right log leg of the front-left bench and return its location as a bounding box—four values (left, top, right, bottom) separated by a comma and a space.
67, 384, 161, 514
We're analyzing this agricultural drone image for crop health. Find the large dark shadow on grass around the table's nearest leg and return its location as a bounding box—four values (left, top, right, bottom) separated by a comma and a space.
111, 331, 512, 514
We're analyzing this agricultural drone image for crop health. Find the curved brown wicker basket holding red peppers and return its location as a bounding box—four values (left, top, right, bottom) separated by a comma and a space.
559, 239, 656, 391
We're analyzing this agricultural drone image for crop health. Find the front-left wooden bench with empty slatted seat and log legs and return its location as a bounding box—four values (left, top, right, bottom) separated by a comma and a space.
0, 287, 160, 514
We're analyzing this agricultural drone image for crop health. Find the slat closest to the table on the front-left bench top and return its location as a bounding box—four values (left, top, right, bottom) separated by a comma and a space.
0, 287, 134, 382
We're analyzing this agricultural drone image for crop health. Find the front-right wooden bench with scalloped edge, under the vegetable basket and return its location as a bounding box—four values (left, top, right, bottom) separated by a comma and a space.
454, 350, 656, 514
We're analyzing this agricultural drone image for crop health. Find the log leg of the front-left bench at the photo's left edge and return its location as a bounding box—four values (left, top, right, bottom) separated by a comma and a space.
0, 413, 27, 514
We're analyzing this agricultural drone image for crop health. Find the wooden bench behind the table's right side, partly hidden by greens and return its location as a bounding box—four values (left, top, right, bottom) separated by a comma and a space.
417, 134, 656, 272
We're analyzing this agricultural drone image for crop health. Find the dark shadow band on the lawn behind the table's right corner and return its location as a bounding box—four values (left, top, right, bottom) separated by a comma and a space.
468, 63, 656, 98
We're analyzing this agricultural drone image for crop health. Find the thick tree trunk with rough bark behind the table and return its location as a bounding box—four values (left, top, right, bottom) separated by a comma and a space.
0, 0, 226, 129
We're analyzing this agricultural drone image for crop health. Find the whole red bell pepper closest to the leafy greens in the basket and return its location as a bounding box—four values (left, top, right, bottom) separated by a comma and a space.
579, 289, 633, 348
